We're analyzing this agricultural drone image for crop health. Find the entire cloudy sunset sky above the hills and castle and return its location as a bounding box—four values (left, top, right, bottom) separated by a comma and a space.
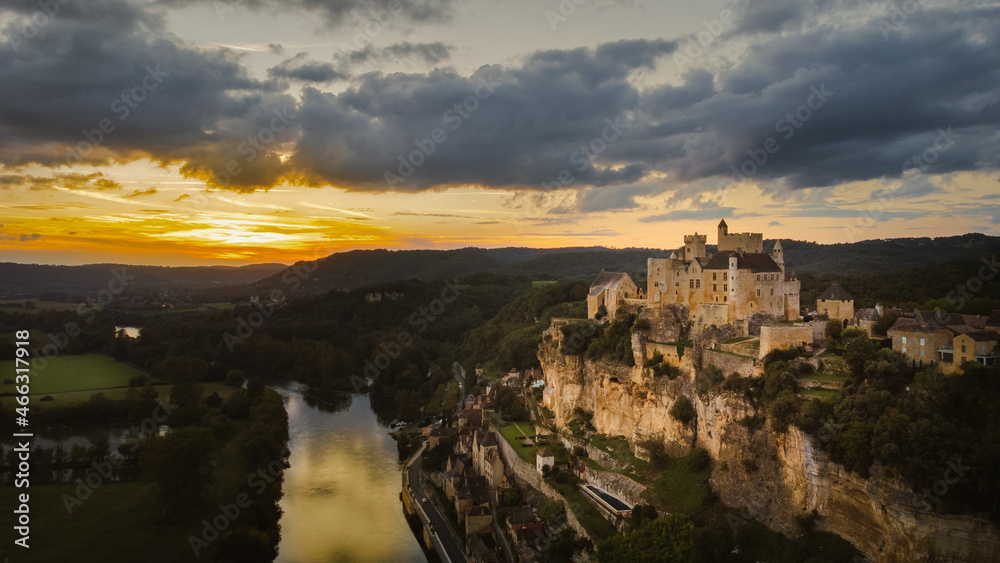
0, 0, 1000, 265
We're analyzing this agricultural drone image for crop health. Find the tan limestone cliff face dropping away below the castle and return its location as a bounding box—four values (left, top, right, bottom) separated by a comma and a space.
538, 311, 1000, 563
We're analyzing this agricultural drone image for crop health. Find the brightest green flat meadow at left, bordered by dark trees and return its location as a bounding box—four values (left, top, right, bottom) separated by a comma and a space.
0, 354, 146, 395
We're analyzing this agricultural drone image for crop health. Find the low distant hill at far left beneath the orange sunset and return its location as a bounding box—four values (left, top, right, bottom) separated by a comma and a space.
0, 262, 286, 297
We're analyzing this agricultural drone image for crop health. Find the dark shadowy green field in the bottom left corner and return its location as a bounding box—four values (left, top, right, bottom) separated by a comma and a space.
0, 416, 258, 563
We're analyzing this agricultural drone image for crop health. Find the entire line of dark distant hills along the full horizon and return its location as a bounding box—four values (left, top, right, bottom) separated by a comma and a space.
0, 233, 1000, 300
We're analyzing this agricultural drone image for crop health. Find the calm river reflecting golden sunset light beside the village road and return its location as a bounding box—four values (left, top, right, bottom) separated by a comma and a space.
272, 384, 427, 563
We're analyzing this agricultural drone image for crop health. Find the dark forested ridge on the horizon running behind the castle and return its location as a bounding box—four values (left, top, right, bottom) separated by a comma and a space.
251, 233, 1000, 298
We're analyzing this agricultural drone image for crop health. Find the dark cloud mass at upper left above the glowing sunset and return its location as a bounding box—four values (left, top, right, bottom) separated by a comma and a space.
0, 0, 295, 189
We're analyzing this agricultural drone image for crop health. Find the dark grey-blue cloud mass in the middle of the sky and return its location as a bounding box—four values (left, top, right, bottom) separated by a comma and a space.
292, 40, 673, 190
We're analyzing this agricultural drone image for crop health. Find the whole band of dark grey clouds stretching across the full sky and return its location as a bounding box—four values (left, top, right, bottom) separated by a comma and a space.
0, 0, 1000, 205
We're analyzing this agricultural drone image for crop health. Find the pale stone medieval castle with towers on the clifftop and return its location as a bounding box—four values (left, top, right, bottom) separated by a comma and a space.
588, 220, 800, 334
